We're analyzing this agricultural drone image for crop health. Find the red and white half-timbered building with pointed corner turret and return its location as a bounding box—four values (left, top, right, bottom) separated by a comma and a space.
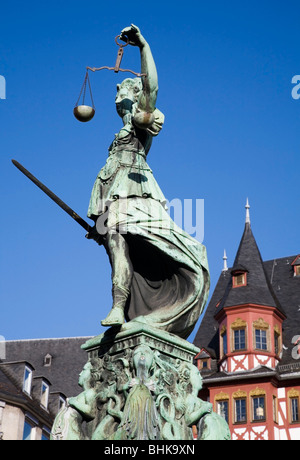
194, 206, 300, 440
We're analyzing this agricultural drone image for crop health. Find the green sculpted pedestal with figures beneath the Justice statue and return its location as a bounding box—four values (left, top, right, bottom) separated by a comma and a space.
52, 321, 229, 440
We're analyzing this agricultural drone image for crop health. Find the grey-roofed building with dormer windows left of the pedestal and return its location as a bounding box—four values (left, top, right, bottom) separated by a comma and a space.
0, 337, 87, 440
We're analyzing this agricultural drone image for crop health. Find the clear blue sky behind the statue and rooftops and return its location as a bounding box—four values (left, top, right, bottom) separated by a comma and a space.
0, 0, 300, 341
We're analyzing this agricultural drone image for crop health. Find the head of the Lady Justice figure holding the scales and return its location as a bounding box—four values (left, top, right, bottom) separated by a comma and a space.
115, 78, 142, 118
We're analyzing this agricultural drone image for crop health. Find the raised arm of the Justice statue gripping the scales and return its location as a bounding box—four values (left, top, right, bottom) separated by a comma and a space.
120, 24, 158, 113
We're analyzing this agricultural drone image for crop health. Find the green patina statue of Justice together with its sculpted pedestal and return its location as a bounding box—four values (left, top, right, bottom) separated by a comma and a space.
51, 25, 230, 441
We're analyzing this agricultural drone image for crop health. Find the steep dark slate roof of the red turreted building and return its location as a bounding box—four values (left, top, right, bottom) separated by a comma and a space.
194, 217, 300, 375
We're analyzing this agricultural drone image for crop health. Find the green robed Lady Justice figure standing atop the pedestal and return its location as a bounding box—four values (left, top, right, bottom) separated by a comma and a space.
87, 25, 210, 338
